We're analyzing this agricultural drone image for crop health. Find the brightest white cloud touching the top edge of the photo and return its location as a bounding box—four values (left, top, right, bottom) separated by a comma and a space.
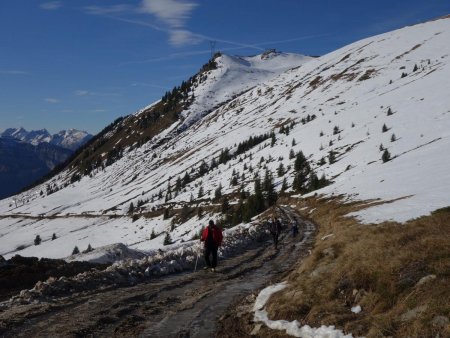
141, 0, 197, 28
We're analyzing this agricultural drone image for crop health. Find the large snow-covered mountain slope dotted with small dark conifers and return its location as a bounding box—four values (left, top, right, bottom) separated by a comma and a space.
0, 18, 450, 257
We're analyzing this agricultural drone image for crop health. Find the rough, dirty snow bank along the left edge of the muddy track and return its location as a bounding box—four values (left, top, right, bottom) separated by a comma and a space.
0, 222, 267, 309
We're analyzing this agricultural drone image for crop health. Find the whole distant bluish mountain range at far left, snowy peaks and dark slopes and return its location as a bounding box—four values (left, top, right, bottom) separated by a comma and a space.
0, 128, 92, 199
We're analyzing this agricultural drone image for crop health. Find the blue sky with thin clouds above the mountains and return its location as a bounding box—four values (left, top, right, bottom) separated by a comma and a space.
0, 0, 450, 133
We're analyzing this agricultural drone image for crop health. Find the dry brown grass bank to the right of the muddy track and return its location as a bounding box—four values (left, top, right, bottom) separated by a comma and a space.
268, 198, 450, 337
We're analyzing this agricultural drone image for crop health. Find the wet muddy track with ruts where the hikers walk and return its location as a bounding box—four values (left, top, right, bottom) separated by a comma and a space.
0, 208, 315, 337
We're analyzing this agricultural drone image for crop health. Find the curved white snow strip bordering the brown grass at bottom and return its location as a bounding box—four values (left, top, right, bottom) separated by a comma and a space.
253, 282, 353, 338
